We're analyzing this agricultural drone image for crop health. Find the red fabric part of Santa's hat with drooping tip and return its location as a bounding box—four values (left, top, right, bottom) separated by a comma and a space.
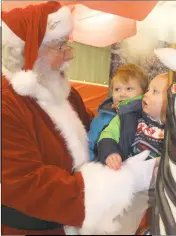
2, 2, 61, 70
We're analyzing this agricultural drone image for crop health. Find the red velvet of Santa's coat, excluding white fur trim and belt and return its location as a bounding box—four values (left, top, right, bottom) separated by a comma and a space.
2, 77, 90, 235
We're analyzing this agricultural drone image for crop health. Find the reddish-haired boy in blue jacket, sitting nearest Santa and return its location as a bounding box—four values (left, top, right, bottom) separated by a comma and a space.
88, 64, 149, 161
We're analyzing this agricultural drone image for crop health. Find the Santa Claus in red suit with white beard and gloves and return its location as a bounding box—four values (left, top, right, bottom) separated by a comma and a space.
2, 2, 158, 235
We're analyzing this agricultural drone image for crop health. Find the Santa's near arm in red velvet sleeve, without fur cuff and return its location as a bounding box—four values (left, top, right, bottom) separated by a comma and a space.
2, 96, 84, 226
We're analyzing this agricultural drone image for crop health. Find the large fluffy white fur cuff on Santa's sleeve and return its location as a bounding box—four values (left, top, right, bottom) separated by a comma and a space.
80, 163, 134, 235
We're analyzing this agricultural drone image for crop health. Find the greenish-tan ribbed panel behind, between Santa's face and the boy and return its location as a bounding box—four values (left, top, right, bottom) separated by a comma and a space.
68, 42, 111, 85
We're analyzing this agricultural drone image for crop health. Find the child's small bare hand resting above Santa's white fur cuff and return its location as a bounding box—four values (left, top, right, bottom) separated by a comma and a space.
106, 153, 122, 170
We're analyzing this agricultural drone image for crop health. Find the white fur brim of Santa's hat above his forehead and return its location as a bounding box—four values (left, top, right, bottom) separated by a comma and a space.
43, 6, 73, 43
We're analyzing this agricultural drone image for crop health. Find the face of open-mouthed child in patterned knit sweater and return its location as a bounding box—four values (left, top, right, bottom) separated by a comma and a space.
142, 74, 168, 122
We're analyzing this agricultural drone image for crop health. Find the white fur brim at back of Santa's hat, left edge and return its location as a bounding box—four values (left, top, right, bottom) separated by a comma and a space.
2, 21, 25, 48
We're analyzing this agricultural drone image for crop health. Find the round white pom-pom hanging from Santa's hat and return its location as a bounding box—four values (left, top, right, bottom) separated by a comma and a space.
10, 71, 37, 96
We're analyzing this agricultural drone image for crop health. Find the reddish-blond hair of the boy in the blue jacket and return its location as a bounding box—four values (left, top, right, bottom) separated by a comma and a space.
111, 64, 149, 93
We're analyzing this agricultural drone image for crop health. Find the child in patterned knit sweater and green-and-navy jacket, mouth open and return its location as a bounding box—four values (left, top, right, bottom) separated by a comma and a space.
98, 74, 168, 170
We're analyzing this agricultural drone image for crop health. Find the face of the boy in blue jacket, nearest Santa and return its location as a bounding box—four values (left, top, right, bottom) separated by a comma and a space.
113, 79, 143, 104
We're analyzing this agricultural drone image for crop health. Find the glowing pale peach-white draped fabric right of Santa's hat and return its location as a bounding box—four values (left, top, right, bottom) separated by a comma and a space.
72, 4, 136, 47
